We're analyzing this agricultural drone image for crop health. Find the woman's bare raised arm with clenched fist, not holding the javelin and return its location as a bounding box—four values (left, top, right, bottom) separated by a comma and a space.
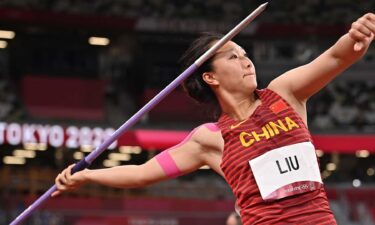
270, 13, 375, 101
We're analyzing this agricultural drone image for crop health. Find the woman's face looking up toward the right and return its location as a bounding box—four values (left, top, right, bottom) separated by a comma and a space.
206, 41, 257, 93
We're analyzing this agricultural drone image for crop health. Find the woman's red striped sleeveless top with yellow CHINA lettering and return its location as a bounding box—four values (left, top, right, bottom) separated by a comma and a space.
217, 89, 336, 225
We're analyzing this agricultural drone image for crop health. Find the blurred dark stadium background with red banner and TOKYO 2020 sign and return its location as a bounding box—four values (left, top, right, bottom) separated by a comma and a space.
0, 0, 375, 225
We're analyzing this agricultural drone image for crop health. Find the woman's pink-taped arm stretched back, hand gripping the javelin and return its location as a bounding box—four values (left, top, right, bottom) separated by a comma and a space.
52, 126, 221, 196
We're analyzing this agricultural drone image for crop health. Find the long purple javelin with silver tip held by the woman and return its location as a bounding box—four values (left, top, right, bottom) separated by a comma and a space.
10, 2, 268, 225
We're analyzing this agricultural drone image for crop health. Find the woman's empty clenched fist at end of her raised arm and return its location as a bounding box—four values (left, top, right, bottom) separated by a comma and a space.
349, 13, 375, 51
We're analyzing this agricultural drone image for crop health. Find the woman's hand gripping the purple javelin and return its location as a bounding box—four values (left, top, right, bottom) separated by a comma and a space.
51, 164, 89, 197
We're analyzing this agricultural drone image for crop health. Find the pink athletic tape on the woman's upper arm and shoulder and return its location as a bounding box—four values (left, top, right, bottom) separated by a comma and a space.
155, 123, 220, 178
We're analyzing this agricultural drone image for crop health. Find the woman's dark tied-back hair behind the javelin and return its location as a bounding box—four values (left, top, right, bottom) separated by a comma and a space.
180, 33, 223, 117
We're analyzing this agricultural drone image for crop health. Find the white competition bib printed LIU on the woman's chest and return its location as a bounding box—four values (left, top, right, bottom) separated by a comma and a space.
249, 142, 323, 201
